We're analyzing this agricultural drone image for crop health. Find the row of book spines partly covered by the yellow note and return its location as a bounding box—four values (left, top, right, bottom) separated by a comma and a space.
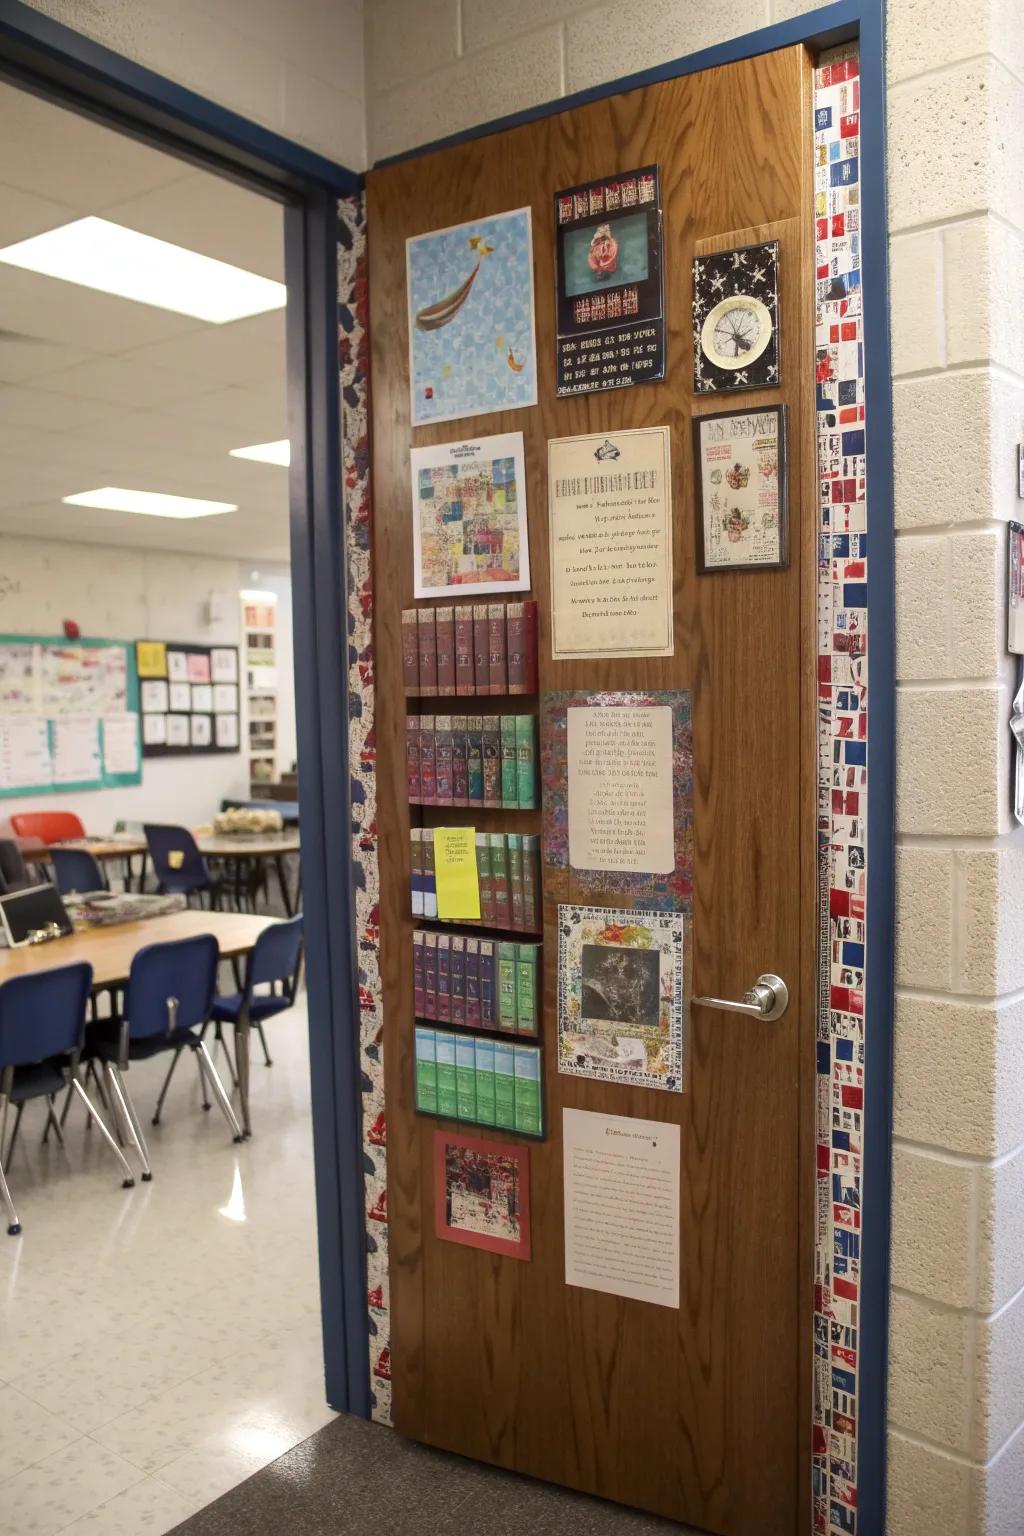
408, 826, 540, 932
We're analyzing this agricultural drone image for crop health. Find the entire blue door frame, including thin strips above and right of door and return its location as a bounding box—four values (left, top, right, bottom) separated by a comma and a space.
0, 0, 895, 1536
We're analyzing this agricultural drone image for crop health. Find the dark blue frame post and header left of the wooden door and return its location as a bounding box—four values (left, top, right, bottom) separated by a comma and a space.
0, 0, 370, 1416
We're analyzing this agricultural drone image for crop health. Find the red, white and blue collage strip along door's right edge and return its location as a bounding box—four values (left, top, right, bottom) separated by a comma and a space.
812, 46, 867, 1536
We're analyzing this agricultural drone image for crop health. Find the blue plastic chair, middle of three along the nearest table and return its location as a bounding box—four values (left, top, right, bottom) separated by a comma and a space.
86, 934, 243, 1183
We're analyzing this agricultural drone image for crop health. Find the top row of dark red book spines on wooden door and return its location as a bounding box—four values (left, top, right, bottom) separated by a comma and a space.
402, 602, 537, 699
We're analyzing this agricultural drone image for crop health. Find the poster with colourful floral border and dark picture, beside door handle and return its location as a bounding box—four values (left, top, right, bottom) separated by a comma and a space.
557, 905, 686, 1094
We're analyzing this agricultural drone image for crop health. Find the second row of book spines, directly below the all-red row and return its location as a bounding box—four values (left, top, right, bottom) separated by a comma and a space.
405, 714, 537, 811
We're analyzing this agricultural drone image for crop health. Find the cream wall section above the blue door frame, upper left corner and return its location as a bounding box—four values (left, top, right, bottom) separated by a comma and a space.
16, 0, 367, 170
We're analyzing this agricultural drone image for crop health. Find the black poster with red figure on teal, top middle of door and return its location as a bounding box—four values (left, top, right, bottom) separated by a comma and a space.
554, 166, 665, 395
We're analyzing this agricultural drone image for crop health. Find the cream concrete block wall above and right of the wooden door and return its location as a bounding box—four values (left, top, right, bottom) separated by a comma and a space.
365, 0, 1024, 1536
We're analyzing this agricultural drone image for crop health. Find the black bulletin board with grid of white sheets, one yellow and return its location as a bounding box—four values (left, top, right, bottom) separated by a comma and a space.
135, 641, 241, 757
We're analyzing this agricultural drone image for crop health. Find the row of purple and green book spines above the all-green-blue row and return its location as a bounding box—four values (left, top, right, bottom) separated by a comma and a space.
413, 928, 540, 1035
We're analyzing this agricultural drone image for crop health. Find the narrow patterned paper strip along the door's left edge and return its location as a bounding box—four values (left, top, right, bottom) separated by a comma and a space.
338, 197, 391, 1424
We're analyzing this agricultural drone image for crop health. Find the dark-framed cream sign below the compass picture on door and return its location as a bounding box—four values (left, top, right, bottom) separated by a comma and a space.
694, 406, 789, 573
